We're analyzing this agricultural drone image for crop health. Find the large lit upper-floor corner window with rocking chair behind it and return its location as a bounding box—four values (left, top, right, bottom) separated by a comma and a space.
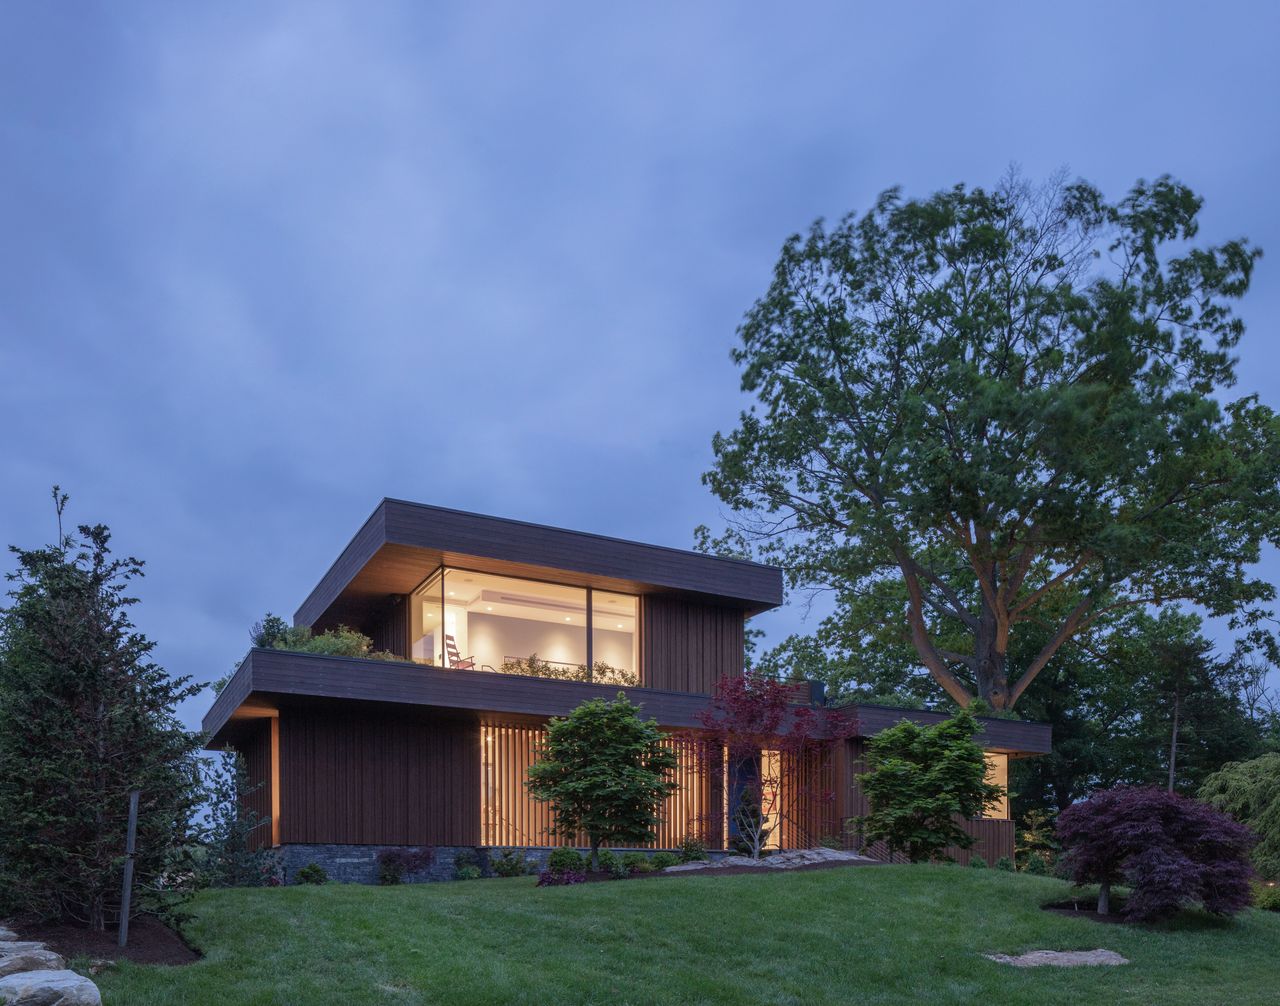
410, 568, 640, 685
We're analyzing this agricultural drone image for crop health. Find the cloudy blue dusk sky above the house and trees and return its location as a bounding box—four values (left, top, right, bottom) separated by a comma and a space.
0, 0, 1280, 724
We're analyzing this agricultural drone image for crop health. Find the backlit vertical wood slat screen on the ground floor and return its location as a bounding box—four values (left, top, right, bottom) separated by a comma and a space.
480, 723, 709, 849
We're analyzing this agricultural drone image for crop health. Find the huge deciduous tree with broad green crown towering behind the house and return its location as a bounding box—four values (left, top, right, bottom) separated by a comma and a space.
705, 170, 1280, 709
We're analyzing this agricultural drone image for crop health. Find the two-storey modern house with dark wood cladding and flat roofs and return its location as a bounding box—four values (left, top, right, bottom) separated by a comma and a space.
204, 499, 1050, 879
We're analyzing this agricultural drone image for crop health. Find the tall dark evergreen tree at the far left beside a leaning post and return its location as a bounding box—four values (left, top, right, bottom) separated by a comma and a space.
0, 486, 201, 929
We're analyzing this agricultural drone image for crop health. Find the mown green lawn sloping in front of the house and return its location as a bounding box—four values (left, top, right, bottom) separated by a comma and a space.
99, 866, 1280, 1006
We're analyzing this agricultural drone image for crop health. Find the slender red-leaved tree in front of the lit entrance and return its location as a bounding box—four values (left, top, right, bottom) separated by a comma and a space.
689, 673, 852, 859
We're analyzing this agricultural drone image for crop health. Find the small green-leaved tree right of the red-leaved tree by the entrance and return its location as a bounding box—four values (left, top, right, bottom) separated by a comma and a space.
860, 709, 1004, 863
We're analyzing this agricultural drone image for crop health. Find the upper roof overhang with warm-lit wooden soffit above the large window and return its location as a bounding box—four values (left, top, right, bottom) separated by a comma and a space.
294, 499, 782, 630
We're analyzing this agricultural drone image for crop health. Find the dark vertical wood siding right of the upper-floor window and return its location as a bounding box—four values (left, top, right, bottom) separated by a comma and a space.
640, 595, 744, 695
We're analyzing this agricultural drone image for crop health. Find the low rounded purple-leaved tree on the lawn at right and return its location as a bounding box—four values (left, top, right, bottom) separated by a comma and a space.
1057, 786, 1254, 922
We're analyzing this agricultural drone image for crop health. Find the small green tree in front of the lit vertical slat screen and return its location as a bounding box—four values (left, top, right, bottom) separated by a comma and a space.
527, 692, 677, 869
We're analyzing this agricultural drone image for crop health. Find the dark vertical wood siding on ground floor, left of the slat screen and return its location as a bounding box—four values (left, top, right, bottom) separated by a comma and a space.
280, 709, 480, 845
